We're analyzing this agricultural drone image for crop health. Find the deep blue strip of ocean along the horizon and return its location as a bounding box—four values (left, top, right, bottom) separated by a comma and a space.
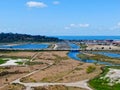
54, 36, 120, 41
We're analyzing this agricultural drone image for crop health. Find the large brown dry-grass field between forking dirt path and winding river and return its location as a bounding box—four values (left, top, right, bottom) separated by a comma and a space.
21, 52, 101, 82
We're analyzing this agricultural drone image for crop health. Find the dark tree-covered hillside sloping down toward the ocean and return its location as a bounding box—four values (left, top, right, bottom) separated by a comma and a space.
0, 33, 62, 43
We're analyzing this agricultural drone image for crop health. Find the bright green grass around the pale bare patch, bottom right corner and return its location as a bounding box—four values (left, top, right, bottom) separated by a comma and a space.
89, 67, 120, 90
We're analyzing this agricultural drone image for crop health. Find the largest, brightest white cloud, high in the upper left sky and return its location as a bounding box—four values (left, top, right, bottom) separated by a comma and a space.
26, 1, 47, 8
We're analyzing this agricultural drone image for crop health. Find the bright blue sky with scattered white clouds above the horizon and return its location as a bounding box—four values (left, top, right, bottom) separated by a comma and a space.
0, 0, 120, 36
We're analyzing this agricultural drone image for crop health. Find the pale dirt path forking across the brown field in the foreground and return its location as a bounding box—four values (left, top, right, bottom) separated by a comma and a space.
0, 52, 92, 90
